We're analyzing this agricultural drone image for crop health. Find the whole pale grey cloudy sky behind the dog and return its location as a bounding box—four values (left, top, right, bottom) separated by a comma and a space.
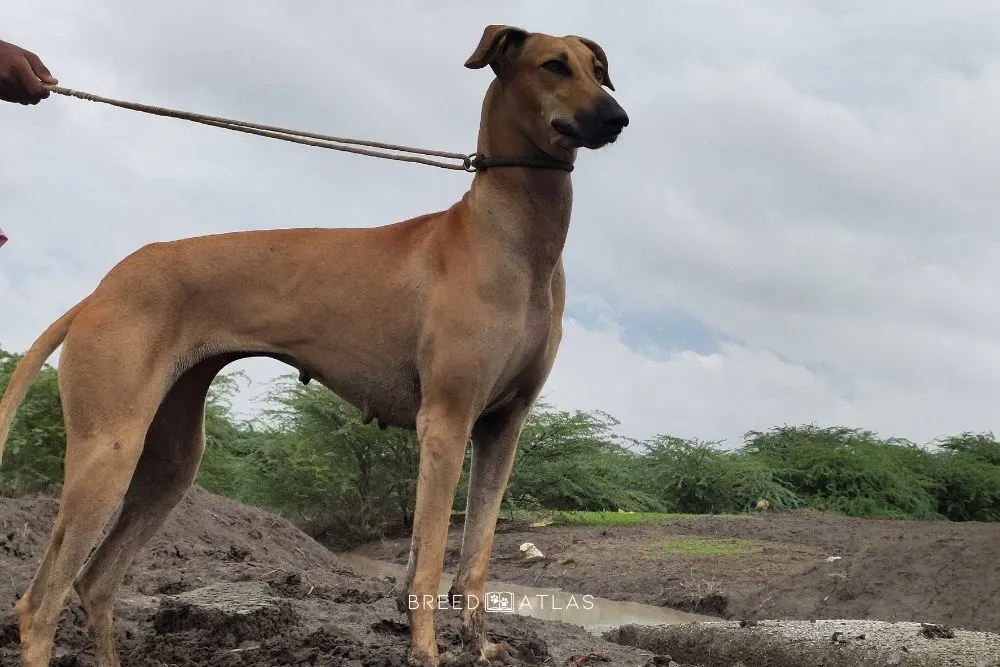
0, 0, 1000, 445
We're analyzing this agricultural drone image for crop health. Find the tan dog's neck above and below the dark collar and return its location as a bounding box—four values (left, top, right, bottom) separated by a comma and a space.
468, 79, 576, 278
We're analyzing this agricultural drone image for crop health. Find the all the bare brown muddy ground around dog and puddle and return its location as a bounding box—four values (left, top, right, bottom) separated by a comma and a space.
0, 489, 1000, 667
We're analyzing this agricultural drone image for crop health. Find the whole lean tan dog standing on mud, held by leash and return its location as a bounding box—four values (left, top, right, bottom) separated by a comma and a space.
0, 26, 628, 667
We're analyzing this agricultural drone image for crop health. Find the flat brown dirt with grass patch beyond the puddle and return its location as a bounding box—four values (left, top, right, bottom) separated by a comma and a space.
356, 511, 1000, 632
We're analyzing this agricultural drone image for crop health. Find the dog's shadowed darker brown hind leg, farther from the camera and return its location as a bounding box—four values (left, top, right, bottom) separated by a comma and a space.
75, 360, 228, 667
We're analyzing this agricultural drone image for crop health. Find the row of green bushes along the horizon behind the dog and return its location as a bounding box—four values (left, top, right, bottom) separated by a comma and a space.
9, 350, 1000, 546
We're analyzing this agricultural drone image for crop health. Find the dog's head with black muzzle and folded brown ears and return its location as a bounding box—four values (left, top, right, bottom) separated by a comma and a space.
465, 25, 628, 150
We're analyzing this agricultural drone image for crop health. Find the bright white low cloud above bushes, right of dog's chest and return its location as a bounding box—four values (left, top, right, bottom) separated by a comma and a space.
546, 319, 854, 446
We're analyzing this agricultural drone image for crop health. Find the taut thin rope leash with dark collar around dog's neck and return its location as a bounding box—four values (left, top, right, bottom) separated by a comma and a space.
45, 85, 573, 173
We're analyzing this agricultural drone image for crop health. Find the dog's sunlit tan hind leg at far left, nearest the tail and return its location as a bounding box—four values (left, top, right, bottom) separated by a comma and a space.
14, 320, 170, 667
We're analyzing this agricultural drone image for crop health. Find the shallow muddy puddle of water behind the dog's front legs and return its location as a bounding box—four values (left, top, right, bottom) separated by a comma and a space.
339, 554, 719, 632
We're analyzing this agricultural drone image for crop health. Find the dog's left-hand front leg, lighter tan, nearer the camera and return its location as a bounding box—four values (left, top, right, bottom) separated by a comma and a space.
399, 394, 472, 667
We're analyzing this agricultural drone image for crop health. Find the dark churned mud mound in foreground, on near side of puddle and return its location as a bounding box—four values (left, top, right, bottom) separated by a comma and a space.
0, 488, 667, 667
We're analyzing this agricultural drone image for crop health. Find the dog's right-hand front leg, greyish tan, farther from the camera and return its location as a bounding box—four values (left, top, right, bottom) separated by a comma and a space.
448, 401, 530, 660
